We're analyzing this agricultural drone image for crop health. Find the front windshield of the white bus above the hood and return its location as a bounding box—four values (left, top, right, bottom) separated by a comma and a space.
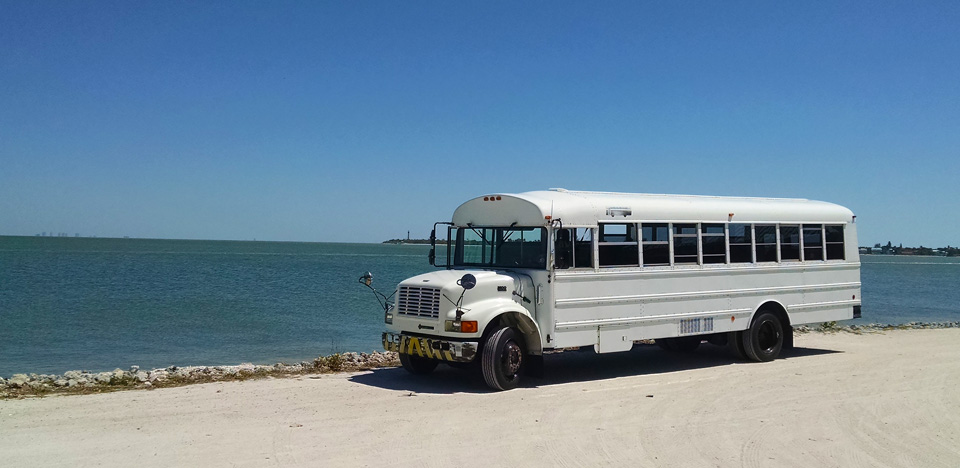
454, 227, 547, 269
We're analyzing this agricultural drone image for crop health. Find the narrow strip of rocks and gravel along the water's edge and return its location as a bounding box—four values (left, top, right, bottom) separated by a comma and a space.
0, 321, 960, 399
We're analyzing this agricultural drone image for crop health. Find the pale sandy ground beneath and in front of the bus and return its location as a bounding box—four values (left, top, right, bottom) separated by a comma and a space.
0, 329, 960, 468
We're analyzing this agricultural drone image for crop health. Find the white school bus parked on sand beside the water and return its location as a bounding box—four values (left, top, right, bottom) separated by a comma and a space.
376, 189, 860, 390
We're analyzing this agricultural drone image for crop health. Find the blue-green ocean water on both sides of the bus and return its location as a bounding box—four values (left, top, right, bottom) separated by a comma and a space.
0, 237, 960, 377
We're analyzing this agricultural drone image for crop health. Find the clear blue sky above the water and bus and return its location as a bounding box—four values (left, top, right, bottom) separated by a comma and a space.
0, 0, 960, 247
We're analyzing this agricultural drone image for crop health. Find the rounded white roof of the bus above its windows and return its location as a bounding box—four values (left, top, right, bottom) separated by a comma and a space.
453, 189, 854, 226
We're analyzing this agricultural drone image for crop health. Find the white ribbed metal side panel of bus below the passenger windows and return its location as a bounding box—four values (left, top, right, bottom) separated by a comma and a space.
554, 262, 859, 352
